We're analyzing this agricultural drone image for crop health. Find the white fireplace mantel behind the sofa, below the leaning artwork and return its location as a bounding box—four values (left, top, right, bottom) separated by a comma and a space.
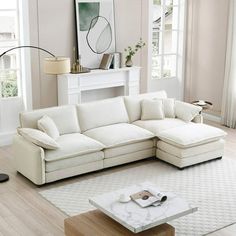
57, 67, 141, 106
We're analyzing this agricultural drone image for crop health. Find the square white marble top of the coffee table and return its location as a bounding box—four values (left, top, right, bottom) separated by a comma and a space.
89, 182, 197, 233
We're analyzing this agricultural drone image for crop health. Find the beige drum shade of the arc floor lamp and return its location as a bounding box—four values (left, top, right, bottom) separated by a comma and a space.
44, 57, 70, 75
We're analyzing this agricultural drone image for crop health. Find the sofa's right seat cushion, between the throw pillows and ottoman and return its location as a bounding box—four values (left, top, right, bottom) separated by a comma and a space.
133, 118, 186, 136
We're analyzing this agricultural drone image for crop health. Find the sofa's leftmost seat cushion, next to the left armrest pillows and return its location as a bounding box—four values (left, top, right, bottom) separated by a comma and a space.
45, 133, 104, 162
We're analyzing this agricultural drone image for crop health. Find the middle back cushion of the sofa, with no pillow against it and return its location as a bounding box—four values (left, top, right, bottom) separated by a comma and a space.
77, 97, 129, 132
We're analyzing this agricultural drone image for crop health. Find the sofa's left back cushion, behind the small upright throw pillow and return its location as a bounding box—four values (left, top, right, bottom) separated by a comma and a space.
20, 105, 80, 135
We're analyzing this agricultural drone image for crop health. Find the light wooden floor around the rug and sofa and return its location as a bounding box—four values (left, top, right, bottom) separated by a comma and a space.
0, 121, 236, 236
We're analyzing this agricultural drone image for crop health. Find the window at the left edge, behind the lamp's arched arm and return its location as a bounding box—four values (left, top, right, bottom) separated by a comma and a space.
0, 0, 21, 98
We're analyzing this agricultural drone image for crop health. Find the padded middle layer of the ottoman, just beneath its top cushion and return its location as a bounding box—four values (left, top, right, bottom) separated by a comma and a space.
157, 139, 225, 158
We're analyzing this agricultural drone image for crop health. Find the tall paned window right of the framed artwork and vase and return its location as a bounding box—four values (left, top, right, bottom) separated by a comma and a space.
152, 0, 182, 79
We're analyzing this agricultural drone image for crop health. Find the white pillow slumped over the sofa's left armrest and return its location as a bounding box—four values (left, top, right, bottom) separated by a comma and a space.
17, 128, 59, 149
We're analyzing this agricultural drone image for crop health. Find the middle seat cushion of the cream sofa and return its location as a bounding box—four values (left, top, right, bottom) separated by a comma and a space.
84, 123, 154, 148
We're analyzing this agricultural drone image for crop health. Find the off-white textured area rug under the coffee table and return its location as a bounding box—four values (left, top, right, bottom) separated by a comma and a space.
40, 158, 236, 236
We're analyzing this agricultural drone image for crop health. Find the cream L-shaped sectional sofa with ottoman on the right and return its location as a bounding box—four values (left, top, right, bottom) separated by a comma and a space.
13, 91, 226, 185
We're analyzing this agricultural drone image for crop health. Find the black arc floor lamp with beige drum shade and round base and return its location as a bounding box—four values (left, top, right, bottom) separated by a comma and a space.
0, 45, 71, 183
